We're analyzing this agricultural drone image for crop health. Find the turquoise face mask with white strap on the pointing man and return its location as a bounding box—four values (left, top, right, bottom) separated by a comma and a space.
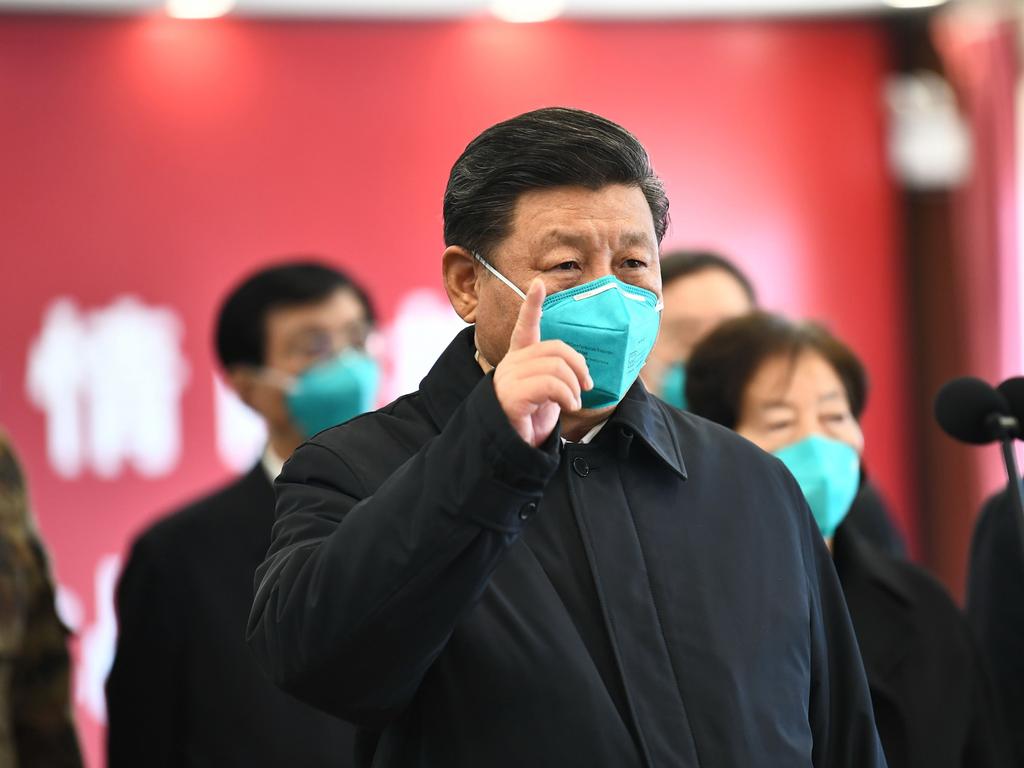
474, 254, 662, 408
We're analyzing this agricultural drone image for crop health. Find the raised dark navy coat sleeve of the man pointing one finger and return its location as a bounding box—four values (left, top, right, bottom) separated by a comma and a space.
249, 376, 558, 728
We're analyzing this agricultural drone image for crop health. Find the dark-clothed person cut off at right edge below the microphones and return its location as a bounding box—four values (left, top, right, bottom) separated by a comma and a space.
967, 490, 1024, 768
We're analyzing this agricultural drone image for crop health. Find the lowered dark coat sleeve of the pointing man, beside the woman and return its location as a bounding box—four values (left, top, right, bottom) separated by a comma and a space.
797, 487, 886, 768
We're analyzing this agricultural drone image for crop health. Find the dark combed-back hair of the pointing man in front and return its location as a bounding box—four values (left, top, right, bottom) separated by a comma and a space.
444, 106, 669, 260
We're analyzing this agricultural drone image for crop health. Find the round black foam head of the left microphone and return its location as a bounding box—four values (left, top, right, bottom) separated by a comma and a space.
935, 376, 1024, 445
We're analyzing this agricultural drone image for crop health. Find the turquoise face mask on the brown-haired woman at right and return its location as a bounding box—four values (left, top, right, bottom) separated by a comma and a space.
775, 435, 860, 539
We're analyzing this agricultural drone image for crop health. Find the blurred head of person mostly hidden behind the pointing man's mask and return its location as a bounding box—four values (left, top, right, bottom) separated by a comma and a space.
640, 251, 758, 410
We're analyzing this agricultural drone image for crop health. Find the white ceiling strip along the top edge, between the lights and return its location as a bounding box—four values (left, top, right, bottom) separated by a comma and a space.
0, 0, 938, 18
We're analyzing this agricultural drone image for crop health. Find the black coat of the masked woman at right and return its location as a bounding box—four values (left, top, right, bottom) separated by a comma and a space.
833, 526, 1009, 768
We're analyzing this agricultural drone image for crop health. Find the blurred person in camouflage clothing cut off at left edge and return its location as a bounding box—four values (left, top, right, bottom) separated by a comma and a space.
0, 432, 82, 768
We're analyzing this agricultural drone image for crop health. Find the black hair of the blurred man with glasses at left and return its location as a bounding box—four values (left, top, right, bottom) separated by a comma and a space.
215, 260, 376, 369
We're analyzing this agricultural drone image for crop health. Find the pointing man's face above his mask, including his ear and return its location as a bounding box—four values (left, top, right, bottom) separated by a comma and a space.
468, 184, 662, 365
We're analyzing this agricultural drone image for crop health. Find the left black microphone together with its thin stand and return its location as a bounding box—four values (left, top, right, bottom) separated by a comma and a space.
935, 376, 1024, 551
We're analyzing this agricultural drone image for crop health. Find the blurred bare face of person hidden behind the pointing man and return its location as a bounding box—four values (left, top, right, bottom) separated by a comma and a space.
651, 267, 754, 366
